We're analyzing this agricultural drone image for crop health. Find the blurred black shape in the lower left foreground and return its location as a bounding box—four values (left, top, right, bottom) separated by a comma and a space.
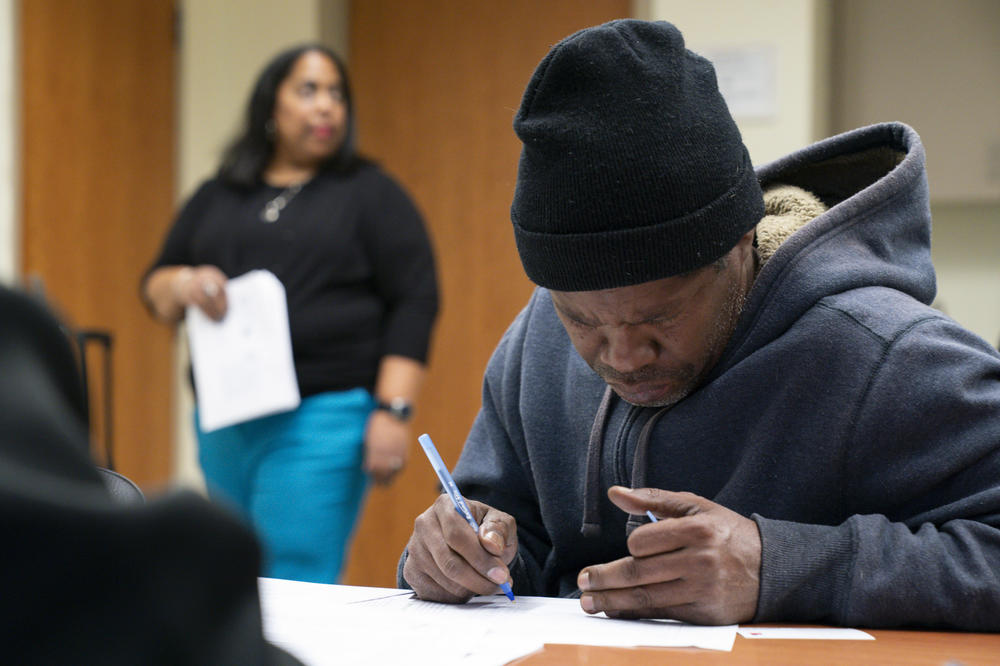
0, 287, 299, 665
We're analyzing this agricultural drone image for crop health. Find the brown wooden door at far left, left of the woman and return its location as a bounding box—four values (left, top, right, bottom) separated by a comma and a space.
20, 0, 174, 486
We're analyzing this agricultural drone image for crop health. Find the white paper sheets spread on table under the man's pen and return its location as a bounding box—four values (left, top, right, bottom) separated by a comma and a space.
260, 578, 736, 666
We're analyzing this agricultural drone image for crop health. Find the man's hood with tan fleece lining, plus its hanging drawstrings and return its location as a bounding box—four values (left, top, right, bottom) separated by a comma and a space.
581, 123, 935, 536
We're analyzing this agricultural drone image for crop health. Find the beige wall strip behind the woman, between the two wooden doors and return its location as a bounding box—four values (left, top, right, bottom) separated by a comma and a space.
174, 0, 347, 487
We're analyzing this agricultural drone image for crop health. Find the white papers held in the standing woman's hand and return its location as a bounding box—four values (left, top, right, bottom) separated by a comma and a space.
186, 270, 301, 432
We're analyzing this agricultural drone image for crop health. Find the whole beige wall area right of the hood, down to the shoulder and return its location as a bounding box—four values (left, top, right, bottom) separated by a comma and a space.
832, 0, 1000, 345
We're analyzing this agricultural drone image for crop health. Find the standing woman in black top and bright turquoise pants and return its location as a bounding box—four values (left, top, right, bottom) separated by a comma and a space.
142, 45, 437, 583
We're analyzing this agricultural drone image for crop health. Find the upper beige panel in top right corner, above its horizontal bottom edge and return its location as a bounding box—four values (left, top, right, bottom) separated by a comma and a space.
833, 0, 1000, 203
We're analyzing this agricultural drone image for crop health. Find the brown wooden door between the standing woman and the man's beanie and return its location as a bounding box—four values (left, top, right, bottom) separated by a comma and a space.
346, 0, 629, 586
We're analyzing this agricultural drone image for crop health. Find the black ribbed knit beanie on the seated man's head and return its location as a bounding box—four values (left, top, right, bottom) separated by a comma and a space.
511, 19, 764, 291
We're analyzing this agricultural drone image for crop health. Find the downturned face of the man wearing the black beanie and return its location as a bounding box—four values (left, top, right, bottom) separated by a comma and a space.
552, 231, 754, 407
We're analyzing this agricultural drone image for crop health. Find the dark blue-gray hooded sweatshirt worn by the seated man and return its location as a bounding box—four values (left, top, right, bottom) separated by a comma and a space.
408, 123, 1000, 631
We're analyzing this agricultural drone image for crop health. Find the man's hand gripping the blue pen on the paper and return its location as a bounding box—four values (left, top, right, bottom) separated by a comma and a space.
403, 495, 517, 603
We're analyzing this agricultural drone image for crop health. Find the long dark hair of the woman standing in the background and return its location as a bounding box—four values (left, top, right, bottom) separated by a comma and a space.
218, 44, 367, 187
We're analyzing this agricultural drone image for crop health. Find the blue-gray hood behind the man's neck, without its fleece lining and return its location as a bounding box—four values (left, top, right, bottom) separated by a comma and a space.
713, 123, 936, 374
